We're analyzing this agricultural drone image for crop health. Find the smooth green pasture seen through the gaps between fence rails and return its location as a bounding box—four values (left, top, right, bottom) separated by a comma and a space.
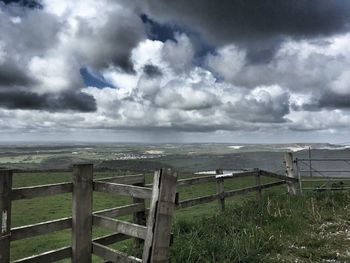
11, 172, 282, 262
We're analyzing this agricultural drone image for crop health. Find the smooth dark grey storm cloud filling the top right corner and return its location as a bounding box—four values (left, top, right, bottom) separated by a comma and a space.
147, 0, 350, 62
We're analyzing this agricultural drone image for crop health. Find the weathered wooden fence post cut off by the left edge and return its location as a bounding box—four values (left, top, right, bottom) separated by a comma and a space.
0, 170, 12, 263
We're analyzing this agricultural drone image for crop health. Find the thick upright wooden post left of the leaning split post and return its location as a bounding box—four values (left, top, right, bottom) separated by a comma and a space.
72, 164, 93, 263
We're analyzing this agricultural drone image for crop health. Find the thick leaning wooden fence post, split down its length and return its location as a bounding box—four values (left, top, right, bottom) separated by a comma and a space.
142, 169, 177, 263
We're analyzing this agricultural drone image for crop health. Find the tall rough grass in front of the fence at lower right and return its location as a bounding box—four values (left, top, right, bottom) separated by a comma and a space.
171, 193, 350, 263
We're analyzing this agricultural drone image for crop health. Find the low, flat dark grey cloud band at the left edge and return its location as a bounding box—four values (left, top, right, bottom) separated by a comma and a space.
0, 90, 96, 112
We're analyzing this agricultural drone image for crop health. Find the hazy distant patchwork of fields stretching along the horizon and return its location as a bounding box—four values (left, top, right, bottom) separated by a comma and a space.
0, 144, 350, 175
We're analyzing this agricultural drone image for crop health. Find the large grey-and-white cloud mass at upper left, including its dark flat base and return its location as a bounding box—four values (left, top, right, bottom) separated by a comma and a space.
0, 0, 146, 112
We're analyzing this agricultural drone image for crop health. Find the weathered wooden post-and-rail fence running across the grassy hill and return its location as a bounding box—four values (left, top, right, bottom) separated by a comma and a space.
0, 154, 298, 263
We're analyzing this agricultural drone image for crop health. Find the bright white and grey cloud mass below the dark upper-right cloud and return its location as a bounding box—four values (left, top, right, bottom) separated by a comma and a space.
0, 0, 350, 142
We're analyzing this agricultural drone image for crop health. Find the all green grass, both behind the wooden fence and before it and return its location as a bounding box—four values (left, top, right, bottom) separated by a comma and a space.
7, 172, 350, 262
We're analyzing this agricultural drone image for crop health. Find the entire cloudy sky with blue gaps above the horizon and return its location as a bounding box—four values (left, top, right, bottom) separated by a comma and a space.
0, 0, 350, 143
